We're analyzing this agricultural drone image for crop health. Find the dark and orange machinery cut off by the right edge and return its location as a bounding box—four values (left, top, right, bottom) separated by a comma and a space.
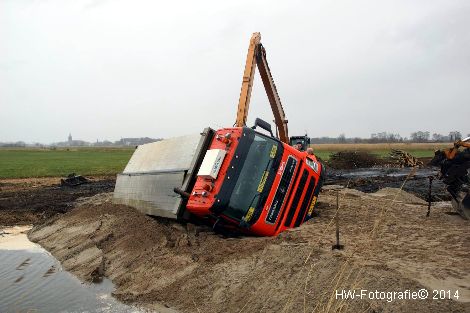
430, 137, 470, 220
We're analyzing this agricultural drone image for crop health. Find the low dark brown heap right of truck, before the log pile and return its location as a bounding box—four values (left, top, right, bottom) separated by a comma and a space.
327, 151, 382, 169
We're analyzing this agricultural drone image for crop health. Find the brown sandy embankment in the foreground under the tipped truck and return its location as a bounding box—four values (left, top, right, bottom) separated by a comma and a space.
29, 188, 470, 312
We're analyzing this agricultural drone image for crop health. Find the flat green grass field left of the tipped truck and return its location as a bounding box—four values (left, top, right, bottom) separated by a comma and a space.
0, 148, 134, 178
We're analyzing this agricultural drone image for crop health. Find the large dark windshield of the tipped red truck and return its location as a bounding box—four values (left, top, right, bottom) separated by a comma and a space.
224, 133, 281, 221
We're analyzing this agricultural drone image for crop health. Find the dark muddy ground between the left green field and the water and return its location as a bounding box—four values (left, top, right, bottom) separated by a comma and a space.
0, 177, 115, 225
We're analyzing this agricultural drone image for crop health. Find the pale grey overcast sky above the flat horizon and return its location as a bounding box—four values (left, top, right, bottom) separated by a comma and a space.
0, 0, 470, 143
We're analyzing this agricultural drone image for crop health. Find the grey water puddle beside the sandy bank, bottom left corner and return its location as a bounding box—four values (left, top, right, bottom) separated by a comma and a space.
0, 226, 143, 313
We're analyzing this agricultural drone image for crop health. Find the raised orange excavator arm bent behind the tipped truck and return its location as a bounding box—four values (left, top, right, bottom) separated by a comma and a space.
235, 33, 289, 144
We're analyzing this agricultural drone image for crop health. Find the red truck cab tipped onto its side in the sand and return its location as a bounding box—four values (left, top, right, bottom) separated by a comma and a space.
186, 127, 324, 236
